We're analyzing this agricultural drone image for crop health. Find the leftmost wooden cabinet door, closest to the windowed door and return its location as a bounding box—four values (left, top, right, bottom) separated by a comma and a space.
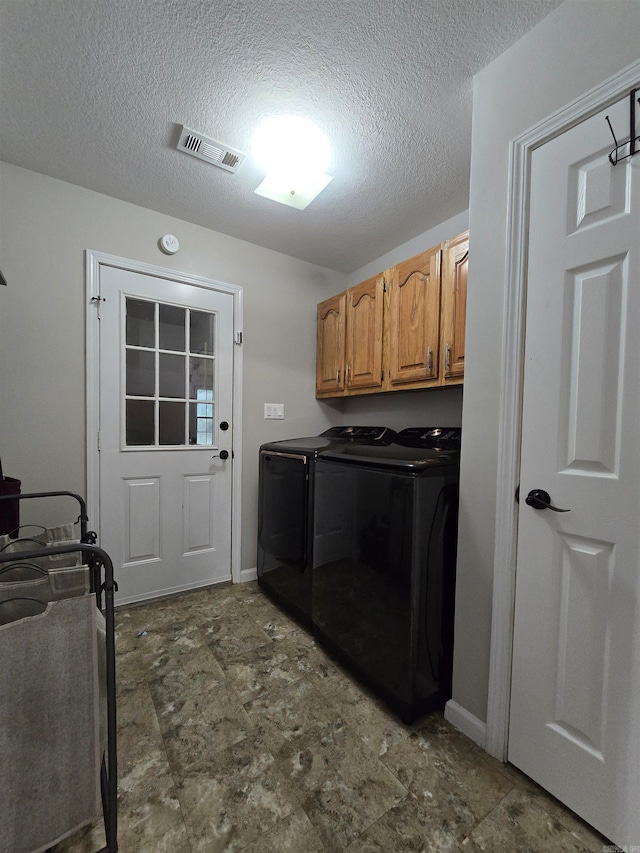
316, 293, 347, 397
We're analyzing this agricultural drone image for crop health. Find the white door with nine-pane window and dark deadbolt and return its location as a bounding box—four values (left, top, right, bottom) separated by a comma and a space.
99, 264, 238, 604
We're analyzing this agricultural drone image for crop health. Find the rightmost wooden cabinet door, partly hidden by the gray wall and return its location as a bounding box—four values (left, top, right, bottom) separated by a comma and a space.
441, 231, 469, 384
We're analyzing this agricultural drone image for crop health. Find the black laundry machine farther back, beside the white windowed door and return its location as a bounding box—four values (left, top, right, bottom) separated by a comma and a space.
258, 426, 396, 625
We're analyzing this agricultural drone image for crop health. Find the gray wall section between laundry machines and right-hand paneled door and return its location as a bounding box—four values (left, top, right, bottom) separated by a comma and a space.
453, 0, 640, 721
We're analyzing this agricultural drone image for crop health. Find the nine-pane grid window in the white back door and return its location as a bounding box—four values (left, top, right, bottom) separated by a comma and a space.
124, 297, 216, 448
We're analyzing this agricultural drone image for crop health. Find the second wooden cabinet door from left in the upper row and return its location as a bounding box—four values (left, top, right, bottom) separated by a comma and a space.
346, 275, 384, 392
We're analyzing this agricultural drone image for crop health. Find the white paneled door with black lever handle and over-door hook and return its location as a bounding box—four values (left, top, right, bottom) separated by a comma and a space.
508, 99, 640, 846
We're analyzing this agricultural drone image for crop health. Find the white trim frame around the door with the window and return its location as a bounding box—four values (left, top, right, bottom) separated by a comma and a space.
85, 249, 243, 583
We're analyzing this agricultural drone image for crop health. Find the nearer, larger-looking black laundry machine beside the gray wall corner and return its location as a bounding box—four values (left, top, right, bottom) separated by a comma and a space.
311, 427, 461, 722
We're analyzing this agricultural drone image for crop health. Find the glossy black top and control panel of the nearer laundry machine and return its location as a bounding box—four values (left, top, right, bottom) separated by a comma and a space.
319, 427, 461, 473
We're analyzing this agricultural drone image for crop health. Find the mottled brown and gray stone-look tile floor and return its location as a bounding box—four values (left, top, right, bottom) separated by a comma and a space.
54, 583, 607, 853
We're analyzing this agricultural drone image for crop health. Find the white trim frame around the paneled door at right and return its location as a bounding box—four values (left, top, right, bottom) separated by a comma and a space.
484, 62, 640, 761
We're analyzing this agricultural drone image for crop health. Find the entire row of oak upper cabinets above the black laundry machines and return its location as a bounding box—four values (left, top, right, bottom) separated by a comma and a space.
316, 232, 469, 398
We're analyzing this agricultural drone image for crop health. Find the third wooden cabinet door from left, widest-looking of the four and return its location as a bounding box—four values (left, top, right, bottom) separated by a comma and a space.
387, 246, 441, 388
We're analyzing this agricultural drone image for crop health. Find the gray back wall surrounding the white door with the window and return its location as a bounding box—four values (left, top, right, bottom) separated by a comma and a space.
0, 163, 345, 568
